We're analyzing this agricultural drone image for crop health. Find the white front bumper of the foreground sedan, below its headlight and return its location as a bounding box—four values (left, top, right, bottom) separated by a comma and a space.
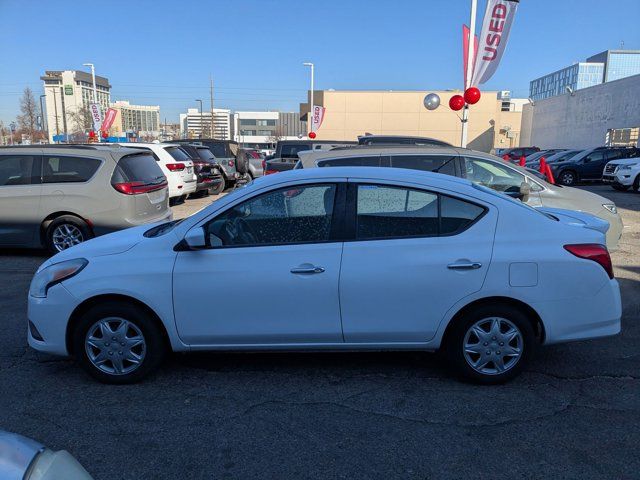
27, 283, 79, 356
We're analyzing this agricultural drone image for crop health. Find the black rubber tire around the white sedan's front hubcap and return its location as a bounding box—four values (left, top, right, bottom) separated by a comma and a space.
72, 301, 168, 385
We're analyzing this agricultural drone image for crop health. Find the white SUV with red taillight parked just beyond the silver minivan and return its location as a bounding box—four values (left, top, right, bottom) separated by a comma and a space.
121, 143, 198, 203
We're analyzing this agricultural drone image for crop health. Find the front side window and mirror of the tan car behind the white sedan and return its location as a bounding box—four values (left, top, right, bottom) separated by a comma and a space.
464, 157, 542, 207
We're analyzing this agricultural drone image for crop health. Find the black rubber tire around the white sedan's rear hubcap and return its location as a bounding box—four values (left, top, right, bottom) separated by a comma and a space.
443, 304, 537, 385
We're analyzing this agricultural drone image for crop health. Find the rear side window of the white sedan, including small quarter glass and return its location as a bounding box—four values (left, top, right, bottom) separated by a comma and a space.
356, 185, 485, 240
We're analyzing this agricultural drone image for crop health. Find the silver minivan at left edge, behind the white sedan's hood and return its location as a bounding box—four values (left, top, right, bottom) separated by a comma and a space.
0, 145, 172, 253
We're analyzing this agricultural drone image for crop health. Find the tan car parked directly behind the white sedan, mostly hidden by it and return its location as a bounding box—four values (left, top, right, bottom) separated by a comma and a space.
295, 145, 623, 250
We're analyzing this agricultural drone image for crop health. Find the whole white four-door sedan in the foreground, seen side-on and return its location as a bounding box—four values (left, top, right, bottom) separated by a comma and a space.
28, 167, 621, 383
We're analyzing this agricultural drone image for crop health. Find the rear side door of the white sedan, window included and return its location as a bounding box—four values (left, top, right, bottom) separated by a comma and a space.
340, 182, 497, 344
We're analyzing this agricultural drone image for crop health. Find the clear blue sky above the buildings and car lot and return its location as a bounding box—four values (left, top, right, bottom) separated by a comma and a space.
0, 0, 640, 124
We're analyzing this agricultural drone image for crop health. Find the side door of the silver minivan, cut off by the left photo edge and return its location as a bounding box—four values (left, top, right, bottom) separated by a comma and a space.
0, 154, 43, 246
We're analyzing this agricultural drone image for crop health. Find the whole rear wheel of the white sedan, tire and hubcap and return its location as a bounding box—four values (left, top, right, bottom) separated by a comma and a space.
444, 305, 536, 385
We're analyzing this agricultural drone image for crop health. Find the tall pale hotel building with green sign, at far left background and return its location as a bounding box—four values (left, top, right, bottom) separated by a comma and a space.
40, 70, 111, 142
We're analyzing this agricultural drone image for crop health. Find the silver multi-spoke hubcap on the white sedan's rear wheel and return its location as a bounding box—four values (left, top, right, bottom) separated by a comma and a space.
464, 317, 523, 375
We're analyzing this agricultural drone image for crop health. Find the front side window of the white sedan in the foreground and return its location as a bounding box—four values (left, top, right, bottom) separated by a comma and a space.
205, 184, 336, 246
